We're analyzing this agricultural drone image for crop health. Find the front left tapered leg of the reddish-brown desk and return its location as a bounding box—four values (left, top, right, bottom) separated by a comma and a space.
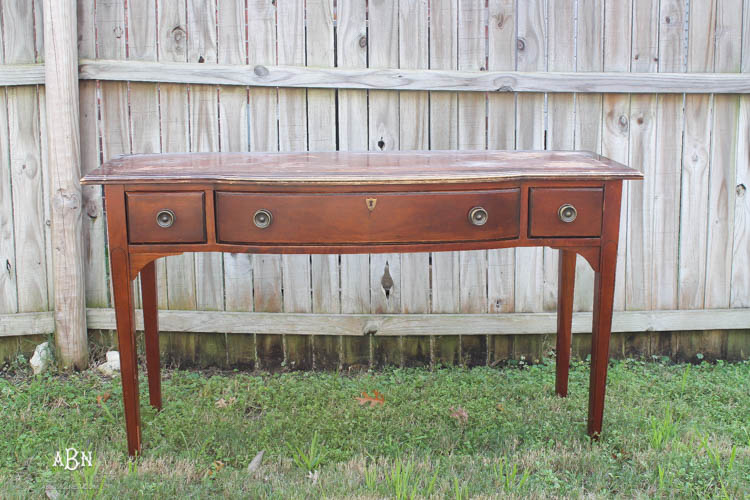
105, 186, 141, 456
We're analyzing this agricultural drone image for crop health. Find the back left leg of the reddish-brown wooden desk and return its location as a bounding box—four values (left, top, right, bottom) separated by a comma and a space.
141, 261, 161, 410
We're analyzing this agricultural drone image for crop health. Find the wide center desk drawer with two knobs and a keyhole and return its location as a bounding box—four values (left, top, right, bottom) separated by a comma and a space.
216, 188, 520, 245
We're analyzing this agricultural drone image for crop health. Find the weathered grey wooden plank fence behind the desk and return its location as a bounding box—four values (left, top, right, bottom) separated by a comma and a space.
0, 0, 750, 367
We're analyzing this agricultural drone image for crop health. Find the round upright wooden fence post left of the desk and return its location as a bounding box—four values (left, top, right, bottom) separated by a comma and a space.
43, 0, 88, 370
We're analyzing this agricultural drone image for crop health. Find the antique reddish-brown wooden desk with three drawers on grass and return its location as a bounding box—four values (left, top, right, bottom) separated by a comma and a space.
81, 151, 642, 455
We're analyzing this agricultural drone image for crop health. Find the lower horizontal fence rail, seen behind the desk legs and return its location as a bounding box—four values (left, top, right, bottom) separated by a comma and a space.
0, 308, 750, 337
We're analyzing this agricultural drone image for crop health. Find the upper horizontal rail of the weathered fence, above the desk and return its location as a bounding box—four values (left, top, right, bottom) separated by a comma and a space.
0, 60, 750, 94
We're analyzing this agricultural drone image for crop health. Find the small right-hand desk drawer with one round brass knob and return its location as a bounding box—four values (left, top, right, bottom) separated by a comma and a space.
529, 188, 604, 238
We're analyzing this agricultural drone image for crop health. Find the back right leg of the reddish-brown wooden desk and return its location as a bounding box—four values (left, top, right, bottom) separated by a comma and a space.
555, 250, 576, 397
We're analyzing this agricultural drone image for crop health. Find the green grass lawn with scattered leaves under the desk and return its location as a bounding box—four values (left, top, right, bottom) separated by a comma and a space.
0, 360, 750, 498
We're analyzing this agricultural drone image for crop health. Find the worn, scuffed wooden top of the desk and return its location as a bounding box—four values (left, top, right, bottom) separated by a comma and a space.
81, 151, 643, 184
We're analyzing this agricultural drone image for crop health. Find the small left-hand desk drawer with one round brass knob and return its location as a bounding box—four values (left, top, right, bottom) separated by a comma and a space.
125, 191, 206, 243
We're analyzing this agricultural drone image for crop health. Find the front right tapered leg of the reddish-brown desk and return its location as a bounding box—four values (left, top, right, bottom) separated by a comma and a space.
588, 181, 622, 439
